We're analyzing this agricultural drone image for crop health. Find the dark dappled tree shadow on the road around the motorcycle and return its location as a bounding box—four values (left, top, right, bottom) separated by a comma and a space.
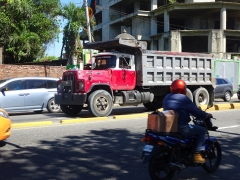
0, 129, 240, 180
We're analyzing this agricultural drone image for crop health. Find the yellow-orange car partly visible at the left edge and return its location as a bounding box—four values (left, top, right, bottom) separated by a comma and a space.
0, 108, 11, 146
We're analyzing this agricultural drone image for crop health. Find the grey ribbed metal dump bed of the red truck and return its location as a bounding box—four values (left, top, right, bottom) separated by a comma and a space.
136, 50, 214, 86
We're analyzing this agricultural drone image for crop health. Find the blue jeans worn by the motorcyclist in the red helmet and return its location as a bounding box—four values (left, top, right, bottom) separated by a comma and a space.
178, 124, 206, 151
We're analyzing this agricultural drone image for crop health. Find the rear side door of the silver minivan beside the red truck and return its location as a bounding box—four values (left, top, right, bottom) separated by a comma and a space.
24, 79, 47, 110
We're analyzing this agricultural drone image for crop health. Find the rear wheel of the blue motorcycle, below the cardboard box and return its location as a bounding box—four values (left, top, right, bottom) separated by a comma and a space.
148, 147, 175, 180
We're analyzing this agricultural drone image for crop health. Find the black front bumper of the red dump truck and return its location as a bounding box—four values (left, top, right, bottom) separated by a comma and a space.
55, 93, 87, 105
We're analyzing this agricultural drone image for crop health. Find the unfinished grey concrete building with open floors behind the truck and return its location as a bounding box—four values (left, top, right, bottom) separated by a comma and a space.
94, 0, 240, 59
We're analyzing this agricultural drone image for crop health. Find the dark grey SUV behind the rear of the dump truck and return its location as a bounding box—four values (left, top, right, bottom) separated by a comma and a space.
214, 78, 233, 102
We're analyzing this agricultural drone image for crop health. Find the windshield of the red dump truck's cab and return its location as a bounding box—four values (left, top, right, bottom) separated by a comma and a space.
94, 55, 117, 69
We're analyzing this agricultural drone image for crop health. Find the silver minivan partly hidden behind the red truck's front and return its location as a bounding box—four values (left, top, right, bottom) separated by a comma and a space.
0, 77, 61, 113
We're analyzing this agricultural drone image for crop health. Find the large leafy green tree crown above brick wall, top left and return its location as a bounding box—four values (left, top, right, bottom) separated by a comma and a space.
0, 0, 61, 63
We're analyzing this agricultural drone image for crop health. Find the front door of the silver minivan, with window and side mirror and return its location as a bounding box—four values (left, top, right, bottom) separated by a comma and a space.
0, 80, 25, 112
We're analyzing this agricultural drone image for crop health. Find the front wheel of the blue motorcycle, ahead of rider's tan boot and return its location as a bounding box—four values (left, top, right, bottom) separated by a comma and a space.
202, 142, 222, 173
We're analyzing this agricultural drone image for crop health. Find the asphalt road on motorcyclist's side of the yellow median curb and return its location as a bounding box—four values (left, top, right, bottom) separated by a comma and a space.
0, 110, 240, 180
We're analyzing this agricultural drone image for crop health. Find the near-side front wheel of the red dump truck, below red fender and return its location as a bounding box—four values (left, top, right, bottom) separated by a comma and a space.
88, 90, 113, 117
